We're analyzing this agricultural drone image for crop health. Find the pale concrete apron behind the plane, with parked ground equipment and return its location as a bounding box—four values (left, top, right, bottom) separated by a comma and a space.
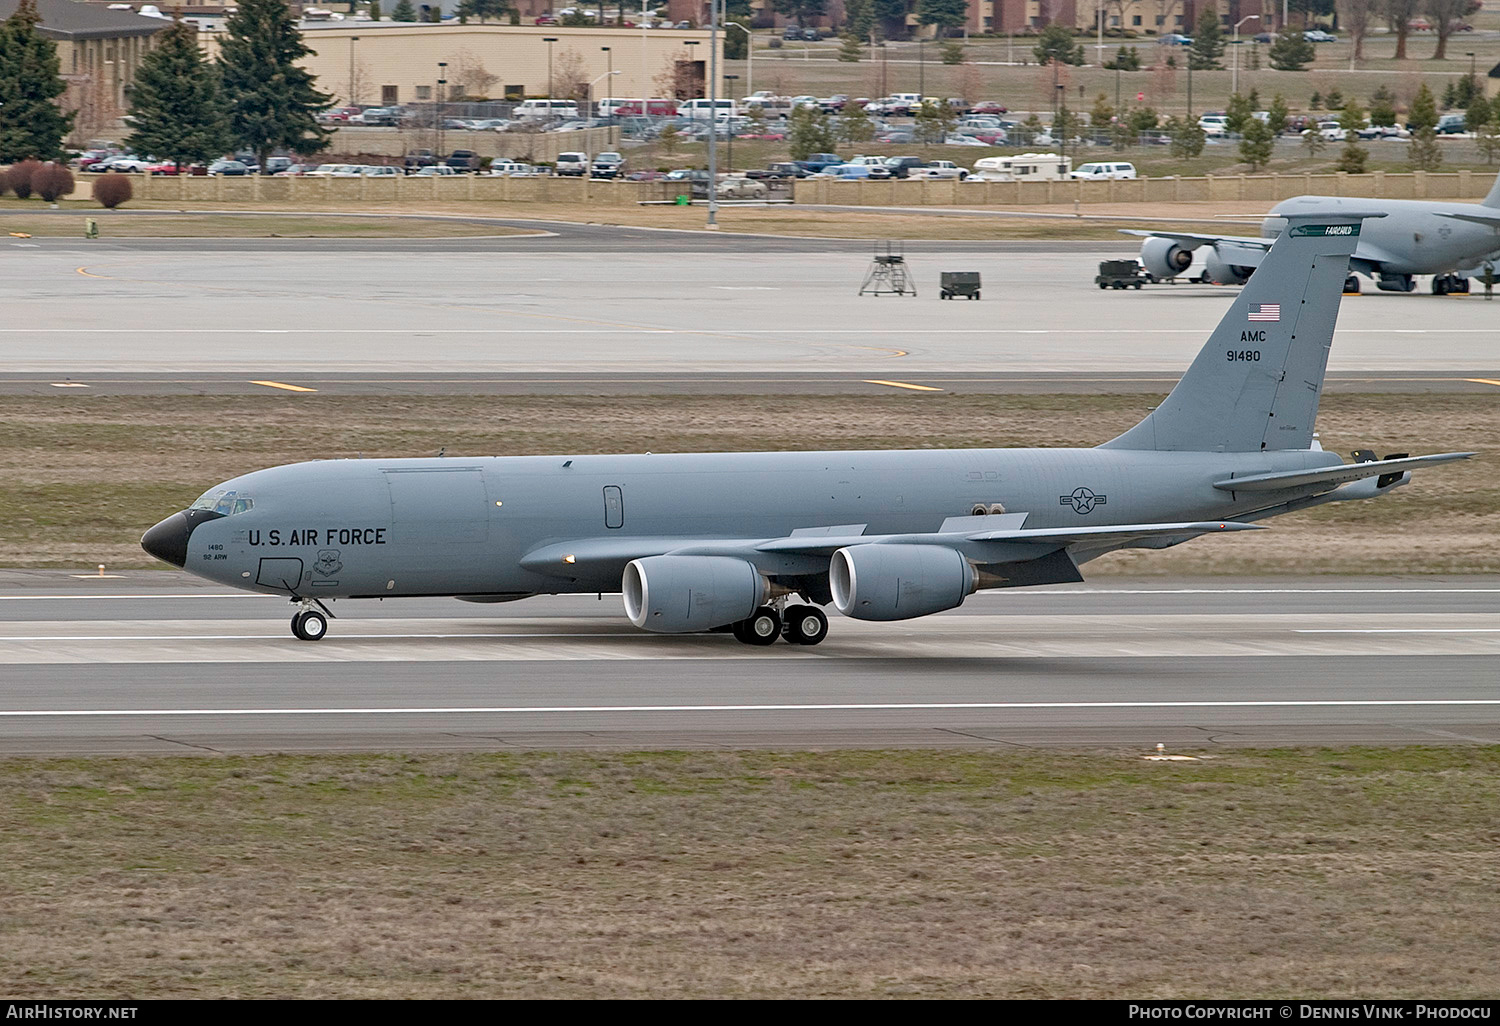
0, 228, 1500, 381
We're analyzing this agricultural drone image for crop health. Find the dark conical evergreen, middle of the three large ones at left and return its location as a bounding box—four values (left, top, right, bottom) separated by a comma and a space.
126, 21, 230, 171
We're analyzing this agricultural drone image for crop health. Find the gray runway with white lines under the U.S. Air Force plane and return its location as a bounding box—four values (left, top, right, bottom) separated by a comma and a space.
0, 572, 1500, 755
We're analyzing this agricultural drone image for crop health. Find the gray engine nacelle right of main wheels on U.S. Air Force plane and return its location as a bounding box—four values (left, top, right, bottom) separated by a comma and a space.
828, 545, 975, 620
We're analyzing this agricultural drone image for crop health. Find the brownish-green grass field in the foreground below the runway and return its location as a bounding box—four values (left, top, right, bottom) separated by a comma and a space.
0, 747, 1500, 999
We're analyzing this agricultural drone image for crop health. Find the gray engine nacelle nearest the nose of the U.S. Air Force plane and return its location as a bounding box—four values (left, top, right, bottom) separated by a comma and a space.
620, 555, 771, 635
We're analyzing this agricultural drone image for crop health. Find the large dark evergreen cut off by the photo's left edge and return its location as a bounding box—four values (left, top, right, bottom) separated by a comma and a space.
0, 0, 74, 164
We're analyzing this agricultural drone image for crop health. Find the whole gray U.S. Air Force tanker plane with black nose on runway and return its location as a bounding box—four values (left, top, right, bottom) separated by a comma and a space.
141, 207, 1473, 645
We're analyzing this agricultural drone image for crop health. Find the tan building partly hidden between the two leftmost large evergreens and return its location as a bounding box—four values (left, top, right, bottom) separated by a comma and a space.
0, 0, 171, 143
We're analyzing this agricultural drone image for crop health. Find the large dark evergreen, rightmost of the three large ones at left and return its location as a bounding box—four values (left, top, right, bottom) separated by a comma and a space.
219, 0, 333, 174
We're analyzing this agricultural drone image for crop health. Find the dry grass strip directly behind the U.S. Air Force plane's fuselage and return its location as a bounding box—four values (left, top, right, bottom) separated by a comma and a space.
0, 393, 1500, 575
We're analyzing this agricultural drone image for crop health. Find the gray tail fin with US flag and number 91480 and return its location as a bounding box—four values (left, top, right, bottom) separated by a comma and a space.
1103, 210, 1385, 453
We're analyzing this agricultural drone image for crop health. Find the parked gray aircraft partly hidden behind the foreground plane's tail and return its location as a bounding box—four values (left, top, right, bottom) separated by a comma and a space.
1122, 171, 1500, 296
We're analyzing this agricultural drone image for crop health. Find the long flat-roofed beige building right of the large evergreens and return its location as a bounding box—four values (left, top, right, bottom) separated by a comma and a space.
271, 23, 725, 107
